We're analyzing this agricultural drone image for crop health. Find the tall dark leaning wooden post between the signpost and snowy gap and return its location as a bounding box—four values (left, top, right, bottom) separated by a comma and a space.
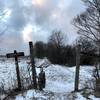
29, 42, 37, 89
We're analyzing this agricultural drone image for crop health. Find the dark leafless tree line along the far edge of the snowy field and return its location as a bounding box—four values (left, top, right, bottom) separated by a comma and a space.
34, 30, 96, 66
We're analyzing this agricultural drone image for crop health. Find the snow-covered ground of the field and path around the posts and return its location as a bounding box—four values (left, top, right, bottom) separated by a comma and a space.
0, 59, 100, 100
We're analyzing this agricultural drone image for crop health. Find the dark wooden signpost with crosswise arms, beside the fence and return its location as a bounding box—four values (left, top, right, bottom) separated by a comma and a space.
6, 50, 24, 90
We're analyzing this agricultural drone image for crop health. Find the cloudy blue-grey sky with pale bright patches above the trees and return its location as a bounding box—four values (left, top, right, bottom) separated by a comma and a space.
0, 0, 85, 54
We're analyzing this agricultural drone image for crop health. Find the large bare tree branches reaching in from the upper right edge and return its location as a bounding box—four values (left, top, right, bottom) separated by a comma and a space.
74, 0, 100, 46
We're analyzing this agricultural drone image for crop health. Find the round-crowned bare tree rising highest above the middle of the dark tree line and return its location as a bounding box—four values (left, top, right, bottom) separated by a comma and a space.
48, 30, 65, 64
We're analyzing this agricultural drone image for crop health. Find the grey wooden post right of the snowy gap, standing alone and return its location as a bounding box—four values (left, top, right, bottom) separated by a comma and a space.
75, 45, 80, 91
